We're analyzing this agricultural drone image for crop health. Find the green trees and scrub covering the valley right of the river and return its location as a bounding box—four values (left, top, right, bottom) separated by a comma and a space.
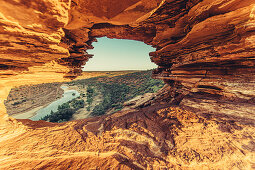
42, 70, 164, 122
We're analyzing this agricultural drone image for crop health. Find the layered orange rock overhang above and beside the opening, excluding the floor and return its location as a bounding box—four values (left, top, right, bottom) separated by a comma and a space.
0, 0, 255, 121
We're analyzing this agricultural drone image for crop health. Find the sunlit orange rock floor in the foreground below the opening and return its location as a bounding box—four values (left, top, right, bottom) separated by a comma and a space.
0, 105, 255, 169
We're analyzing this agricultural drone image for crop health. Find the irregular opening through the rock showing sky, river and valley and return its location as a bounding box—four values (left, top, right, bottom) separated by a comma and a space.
5, 37, 164, 122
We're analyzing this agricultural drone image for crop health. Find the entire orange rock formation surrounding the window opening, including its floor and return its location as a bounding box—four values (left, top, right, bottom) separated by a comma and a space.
0, 0, 255, 169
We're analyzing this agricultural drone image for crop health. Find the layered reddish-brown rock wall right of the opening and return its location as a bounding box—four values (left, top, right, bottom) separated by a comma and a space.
151, 1, 255, 123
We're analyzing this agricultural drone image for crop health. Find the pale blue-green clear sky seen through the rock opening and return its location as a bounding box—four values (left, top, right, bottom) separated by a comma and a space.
83, 37, 156, 71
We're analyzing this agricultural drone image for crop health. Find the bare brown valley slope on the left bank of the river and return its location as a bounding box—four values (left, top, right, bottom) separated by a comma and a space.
5, 83, 64, 118
